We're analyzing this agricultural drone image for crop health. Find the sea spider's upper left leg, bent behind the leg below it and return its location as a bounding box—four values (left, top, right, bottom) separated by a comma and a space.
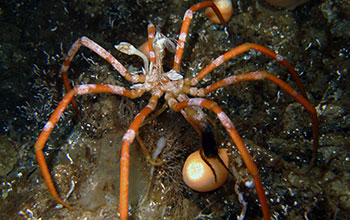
60, 37, 145, 127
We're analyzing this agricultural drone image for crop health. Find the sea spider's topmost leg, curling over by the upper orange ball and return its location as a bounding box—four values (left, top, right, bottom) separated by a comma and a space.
173, 1, 226, 72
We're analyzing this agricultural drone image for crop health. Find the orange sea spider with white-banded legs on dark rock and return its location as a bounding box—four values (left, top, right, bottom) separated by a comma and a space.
35, 1, 318, 219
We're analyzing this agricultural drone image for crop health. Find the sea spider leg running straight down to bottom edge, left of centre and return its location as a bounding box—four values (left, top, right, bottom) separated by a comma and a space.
119, 95, 158, 220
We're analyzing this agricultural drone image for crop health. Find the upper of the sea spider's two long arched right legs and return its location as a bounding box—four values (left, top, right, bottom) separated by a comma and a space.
186, 43, 307, 98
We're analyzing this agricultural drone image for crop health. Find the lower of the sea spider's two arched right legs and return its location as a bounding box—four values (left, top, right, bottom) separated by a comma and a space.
190, 71, 319, 164
